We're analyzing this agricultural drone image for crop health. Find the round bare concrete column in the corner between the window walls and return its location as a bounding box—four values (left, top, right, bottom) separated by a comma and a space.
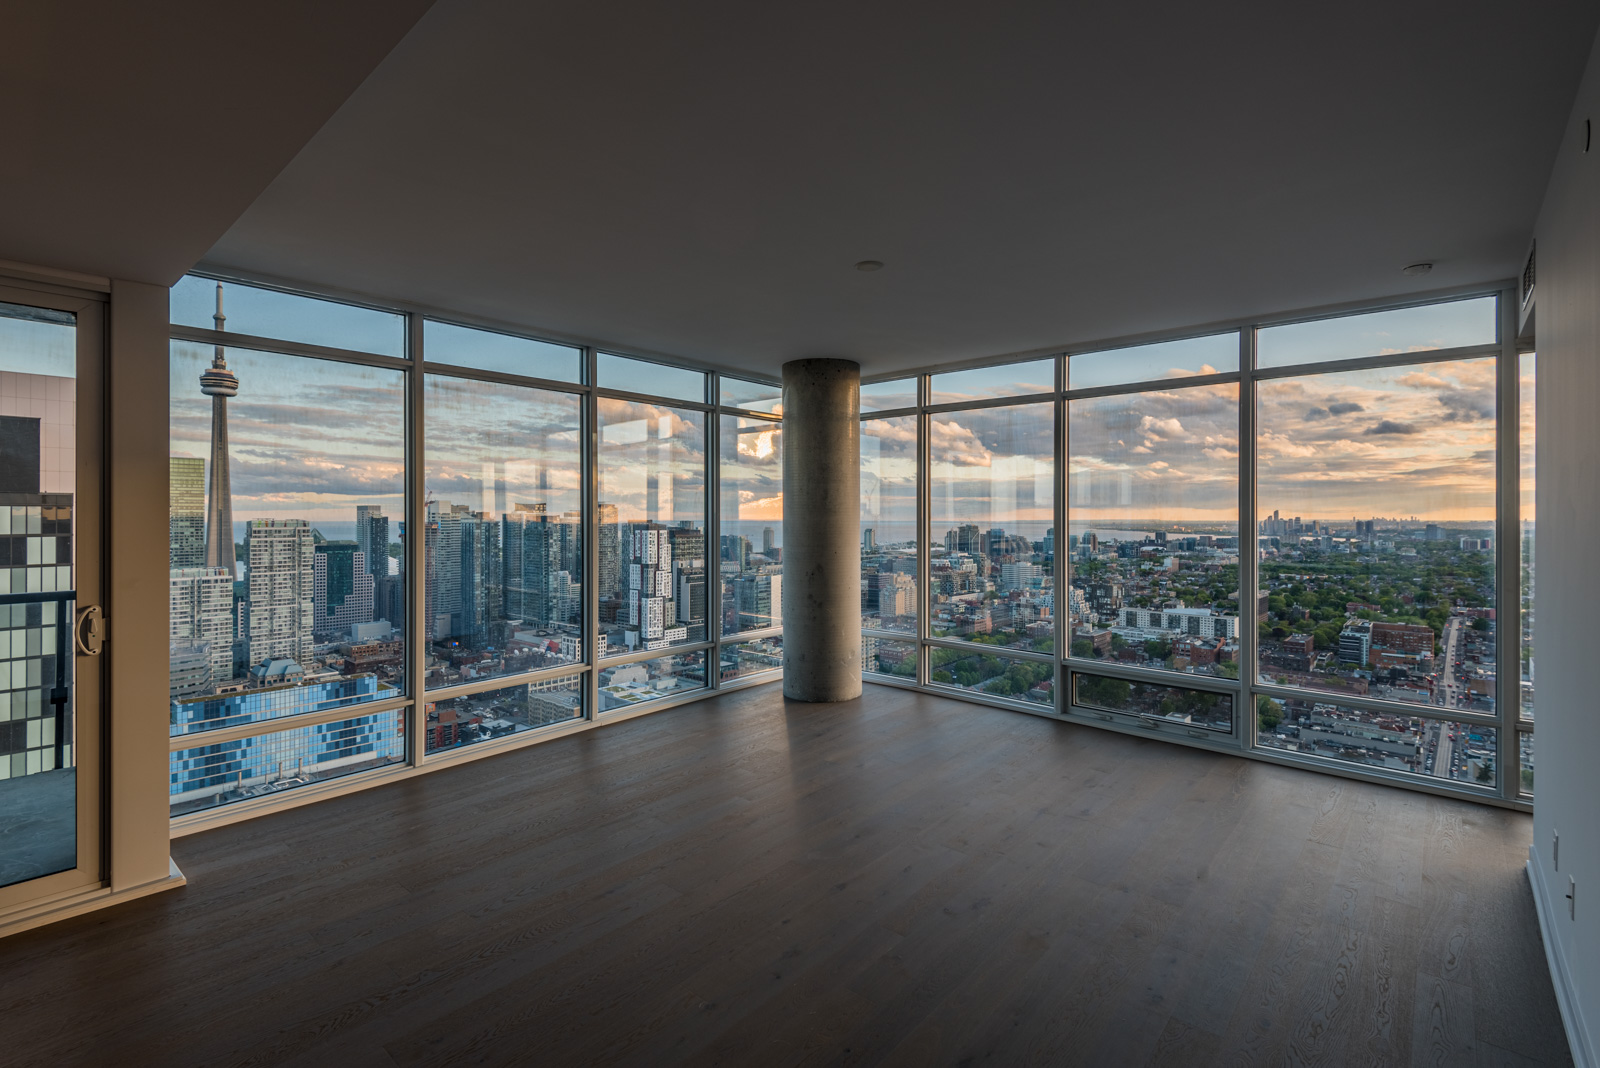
782, 360, 861, 700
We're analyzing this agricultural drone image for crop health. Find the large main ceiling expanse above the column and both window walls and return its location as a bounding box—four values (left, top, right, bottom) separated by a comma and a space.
190, 0, 1600, 374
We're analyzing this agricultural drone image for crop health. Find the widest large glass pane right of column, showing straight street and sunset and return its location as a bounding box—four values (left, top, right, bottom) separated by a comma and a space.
1256, 358, 1494, 711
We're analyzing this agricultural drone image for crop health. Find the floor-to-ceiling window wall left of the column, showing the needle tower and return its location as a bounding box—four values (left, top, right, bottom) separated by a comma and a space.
170, 277, 782, 827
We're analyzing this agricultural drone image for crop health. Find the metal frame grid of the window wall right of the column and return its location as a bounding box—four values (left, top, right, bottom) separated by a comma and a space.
861, 281, 1534, 811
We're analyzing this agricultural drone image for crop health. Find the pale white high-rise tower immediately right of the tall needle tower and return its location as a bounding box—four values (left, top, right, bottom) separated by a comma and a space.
245, 520, 315, 667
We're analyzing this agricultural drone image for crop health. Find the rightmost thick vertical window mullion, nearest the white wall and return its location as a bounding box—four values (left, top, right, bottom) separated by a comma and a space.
1494, 289, 1522, 799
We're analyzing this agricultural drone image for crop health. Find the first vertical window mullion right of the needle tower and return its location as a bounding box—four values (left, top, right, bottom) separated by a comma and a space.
400, 315, 427, 767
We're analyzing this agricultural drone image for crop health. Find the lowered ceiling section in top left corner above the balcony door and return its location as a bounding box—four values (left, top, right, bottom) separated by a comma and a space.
0, 0, 427, 285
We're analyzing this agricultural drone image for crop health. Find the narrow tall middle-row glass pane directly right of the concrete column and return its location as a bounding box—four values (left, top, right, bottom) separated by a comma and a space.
861, 416, 917, 633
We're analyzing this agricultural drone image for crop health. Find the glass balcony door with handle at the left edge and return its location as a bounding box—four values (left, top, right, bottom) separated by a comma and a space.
0, 285, 104, 915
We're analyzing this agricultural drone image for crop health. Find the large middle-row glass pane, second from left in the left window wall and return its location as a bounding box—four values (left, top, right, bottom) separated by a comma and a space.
424, 374, 584, 689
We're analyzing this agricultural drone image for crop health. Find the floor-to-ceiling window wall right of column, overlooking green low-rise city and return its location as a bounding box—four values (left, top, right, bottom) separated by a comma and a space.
861, 293, 1533, 803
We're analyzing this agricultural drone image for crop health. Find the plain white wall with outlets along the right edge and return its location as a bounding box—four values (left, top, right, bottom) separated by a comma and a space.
1531, 20, 1600, 1065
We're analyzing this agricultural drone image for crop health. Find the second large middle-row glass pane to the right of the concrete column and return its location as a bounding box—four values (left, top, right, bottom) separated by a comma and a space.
928, 403, 1056, 652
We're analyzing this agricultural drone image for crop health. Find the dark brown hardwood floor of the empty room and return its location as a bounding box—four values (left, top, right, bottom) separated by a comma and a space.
0, 686, 1570, 1068
